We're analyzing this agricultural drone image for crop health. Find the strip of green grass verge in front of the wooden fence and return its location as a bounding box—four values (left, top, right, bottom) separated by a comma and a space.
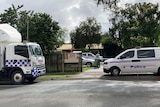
37, 67, 92, 80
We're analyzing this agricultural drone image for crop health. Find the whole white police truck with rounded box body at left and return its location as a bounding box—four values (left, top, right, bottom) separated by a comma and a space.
0, 24, 46, 84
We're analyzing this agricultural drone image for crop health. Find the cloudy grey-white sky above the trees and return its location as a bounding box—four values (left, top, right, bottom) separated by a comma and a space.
0, 0, 160, 42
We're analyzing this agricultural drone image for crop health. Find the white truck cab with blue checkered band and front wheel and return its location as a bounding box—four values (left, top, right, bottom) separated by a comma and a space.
3, 43, 46, 84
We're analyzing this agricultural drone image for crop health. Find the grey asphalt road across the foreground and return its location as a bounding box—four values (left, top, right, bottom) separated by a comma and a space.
0, 65, 160, 107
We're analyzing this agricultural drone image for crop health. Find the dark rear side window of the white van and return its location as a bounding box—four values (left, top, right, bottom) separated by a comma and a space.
137, 49, 155, 58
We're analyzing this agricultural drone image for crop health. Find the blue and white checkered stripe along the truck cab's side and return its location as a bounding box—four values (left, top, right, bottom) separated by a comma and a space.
5, 59, 31, 67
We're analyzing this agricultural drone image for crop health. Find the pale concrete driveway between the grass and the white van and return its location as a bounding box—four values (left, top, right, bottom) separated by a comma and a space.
72, 66, 105, 79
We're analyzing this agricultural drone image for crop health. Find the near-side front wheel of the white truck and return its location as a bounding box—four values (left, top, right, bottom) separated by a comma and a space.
11, 71, 24, 85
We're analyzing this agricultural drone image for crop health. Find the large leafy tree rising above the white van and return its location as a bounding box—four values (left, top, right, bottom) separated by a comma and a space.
109, 3, 160, 48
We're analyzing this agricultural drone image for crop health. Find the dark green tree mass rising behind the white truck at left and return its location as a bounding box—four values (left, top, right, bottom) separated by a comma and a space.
0, 5, 65, 54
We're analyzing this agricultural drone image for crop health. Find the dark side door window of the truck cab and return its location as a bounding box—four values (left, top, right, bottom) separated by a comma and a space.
15, 45, 29, 58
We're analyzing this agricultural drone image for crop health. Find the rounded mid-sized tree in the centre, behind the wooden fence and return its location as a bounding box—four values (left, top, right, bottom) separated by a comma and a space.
70, 17, 101, 49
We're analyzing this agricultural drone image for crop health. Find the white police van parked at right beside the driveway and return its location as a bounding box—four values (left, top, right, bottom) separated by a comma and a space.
103, 47, 160, 76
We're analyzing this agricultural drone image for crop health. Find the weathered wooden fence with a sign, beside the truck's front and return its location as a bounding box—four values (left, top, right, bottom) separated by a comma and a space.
45, 51, 82, 72
